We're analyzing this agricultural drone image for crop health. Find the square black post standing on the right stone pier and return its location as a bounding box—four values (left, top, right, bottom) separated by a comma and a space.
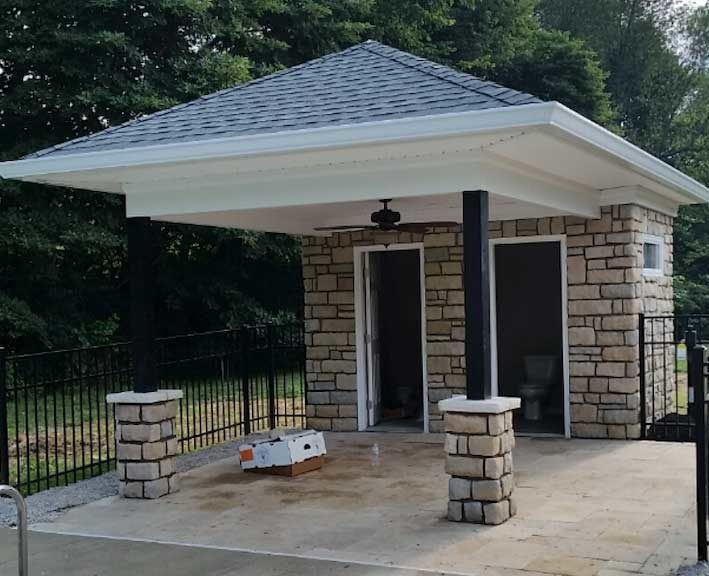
463, 190, 492, 400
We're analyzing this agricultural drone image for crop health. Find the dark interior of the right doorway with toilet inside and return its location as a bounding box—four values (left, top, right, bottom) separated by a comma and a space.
494, 242, 564, 434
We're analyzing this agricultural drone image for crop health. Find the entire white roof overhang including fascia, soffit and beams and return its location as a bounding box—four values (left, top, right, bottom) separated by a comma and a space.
0, 102, 709, 232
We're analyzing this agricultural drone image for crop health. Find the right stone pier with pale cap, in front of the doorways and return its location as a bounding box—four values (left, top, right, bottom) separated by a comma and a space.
439, 396, 520, 524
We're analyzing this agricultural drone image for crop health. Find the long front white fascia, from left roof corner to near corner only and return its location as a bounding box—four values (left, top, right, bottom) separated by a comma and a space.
0, 103, 553, 179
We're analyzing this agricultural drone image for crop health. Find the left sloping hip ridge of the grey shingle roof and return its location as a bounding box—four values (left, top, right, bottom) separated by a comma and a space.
24, 40, 370, 158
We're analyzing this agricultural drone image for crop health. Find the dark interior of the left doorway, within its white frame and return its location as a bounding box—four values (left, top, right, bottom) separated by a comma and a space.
369, 250, 423, 429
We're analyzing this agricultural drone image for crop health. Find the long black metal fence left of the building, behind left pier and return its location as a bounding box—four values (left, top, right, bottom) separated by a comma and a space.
0, 324, 305, 494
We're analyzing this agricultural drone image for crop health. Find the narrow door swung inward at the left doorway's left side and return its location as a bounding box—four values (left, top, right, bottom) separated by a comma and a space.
364, 252, 382, 426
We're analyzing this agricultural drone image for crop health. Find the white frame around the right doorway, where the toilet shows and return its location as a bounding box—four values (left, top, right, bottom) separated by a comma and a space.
490, 234, 571, 438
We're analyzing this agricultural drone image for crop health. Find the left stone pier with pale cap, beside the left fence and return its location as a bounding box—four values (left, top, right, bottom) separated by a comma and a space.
106, 390, 182, 499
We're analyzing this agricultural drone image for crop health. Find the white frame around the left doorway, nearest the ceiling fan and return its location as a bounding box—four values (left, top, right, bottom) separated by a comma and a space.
354, 242, 428, 432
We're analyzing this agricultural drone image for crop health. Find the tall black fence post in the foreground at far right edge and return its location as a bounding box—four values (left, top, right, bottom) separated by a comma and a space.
686, 331, 707, 562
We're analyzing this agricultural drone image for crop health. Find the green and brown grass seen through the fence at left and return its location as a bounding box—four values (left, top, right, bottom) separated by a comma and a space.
7, 372, 305, 493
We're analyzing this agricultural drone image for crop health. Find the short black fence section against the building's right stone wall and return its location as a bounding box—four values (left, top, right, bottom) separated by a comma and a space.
639, 314, 709, 442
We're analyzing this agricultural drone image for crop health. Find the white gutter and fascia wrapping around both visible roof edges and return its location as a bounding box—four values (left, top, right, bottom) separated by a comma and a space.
0, 102, 709, 203
